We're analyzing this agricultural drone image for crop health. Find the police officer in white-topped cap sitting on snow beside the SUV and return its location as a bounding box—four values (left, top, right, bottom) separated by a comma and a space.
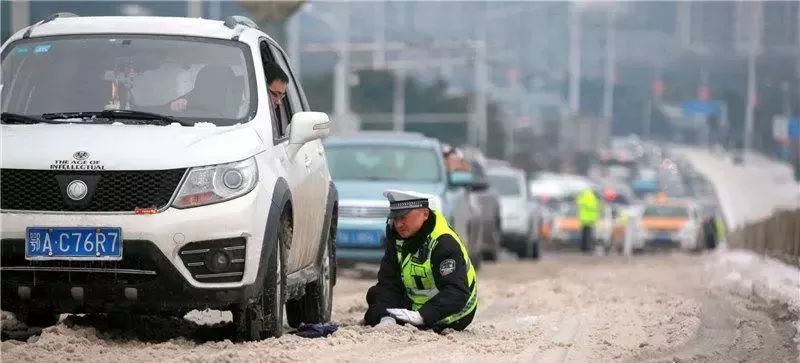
364, 190, 478, 331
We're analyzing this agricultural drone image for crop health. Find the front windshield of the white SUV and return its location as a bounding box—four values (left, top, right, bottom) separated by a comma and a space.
2, 35, 256, 126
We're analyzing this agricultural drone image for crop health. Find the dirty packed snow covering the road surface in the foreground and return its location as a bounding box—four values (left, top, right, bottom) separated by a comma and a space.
2, 253, 798, 362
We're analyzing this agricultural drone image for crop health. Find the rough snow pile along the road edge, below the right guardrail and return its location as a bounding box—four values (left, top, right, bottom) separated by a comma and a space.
705, 248, 800, 350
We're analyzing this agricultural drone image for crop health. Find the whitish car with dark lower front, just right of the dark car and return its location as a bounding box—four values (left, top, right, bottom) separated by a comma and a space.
488, 166, 541, 258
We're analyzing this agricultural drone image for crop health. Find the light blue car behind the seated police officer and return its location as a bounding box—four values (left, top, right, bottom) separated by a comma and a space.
325, 132, 481, 265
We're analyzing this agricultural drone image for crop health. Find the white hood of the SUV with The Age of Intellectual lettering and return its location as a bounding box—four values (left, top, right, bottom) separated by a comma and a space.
0, 124, 263, 170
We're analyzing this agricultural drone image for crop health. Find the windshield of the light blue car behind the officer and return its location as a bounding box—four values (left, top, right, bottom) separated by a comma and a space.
325, 145, 442, 182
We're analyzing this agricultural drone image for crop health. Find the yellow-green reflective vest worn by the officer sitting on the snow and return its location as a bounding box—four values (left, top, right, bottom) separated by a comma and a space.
397, 210, 478, 325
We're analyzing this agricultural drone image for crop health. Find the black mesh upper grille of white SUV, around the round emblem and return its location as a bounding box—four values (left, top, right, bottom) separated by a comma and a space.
0, 169, 186, 212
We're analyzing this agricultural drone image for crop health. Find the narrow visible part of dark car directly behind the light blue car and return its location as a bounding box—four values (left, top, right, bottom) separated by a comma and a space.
462, 147, 502, 261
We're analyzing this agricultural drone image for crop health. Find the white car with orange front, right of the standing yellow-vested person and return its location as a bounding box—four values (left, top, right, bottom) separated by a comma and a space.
633, 194, 704, 250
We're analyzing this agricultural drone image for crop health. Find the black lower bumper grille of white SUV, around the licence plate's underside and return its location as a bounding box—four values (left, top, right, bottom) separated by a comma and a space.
0, 239, 164, 284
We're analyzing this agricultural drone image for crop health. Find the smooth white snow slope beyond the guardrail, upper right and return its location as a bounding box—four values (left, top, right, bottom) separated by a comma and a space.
679, 148, 800, 229
